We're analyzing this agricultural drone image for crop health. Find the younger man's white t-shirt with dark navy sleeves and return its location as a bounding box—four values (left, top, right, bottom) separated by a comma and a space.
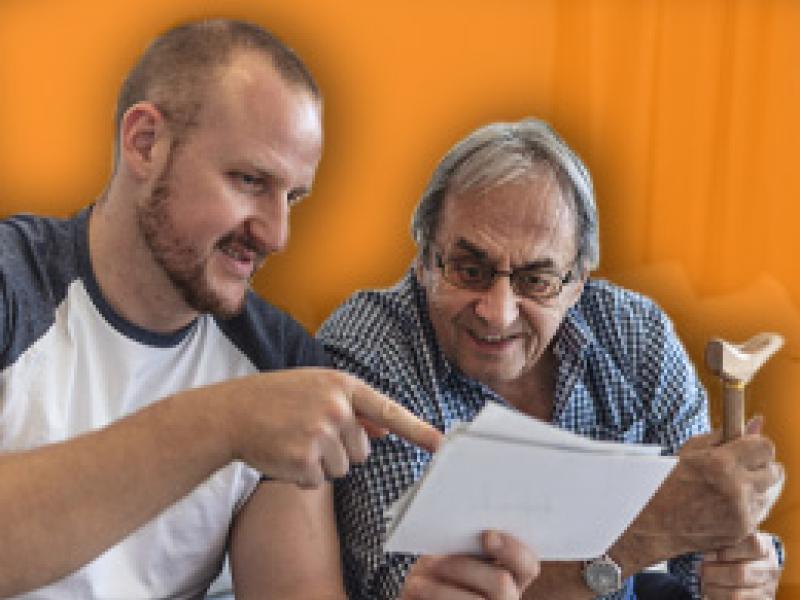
0, 210, 325, 600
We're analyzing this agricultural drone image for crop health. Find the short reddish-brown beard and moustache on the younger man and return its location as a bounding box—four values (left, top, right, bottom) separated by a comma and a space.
136, 147, 255, 319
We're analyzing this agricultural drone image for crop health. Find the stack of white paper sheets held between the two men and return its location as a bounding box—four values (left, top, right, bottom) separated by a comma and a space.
384, 404, 677, 560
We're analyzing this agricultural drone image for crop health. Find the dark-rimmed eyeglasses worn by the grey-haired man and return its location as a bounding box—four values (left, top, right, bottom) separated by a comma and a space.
435, 251, 574, 300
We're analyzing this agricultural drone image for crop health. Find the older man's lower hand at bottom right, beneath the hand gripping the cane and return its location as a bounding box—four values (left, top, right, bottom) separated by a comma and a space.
700, 532, 781, 600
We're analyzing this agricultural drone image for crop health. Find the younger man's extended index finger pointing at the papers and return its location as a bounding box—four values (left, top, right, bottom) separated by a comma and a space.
350, 382, 444, 452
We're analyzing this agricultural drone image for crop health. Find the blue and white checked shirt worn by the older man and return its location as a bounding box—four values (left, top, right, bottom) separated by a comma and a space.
317, 270, 708, 600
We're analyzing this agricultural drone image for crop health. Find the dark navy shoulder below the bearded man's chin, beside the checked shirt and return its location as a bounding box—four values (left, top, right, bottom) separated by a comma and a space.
217, 292, 329, 370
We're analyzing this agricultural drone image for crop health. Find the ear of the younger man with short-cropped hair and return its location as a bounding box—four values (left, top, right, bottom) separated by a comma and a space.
120, 102, 170, 179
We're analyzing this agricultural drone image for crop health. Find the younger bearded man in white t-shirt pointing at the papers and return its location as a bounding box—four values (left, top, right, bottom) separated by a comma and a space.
0, 21, 538, 600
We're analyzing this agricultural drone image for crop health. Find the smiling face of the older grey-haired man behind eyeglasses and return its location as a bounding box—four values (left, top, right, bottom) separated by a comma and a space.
418, 165, 583, 389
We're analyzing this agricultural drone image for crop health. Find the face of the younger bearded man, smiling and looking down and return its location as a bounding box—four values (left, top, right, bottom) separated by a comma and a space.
138, 52, 322, 316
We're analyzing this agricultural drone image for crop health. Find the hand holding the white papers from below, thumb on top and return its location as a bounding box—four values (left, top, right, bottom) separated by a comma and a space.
401, 531, 539, 600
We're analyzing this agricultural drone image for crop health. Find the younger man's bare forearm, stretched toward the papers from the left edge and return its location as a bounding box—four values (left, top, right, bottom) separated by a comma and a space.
0, 395, 230, 597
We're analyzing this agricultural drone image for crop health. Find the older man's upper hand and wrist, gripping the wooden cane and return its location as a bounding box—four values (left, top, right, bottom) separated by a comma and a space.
630, 427, 784, 562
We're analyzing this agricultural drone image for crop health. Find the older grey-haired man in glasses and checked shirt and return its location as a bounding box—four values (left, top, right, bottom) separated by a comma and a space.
318, 119, 783, 599
